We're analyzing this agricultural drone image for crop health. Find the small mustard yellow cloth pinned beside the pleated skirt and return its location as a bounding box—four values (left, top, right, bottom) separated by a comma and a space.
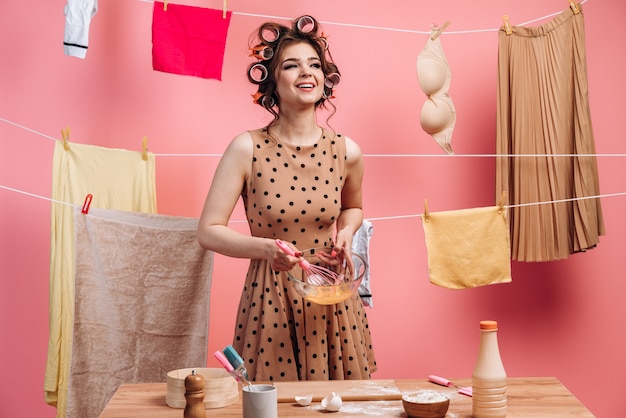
422, 206, 511, 289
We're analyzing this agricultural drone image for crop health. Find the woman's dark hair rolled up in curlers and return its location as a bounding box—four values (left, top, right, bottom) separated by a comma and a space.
248, 15, 340, 126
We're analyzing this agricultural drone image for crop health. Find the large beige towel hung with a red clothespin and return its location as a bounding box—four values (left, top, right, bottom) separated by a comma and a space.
67, 207, 213, 418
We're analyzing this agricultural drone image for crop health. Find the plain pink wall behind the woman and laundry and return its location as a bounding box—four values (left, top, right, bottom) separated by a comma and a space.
0, 0, 626, 418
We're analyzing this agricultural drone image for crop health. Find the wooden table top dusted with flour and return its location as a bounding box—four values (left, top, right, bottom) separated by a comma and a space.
100, 377, 593, 418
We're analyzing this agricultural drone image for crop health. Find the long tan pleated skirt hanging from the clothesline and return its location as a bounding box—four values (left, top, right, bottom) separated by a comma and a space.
496, 4, 604, 262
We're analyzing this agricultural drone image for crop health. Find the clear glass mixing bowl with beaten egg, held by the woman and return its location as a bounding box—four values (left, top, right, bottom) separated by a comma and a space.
288, 248, 367, 305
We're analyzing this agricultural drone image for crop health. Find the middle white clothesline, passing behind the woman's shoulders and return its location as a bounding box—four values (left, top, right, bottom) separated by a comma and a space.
0, 117, 626, 158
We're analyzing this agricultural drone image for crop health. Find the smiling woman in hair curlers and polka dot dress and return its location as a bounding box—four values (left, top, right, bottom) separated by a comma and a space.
198, 16, 376, 381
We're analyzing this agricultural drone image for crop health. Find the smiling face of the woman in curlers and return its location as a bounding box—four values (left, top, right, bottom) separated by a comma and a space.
276, 42, 324, 108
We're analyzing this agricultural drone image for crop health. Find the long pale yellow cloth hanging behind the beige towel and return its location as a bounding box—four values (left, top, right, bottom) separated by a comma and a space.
44, 141, 156, 418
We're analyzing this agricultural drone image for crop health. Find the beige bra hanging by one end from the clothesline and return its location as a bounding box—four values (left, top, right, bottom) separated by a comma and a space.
417, 32, 456, 154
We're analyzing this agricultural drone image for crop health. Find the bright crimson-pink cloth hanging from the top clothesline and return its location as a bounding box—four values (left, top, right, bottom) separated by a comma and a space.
152, 1, 232, 80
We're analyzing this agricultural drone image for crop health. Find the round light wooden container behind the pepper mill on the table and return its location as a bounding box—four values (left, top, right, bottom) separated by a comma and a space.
165, 367, 239, 409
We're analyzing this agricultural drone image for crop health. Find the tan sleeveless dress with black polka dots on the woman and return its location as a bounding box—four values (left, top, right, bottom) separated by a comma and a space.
233, 130, 376, 381
